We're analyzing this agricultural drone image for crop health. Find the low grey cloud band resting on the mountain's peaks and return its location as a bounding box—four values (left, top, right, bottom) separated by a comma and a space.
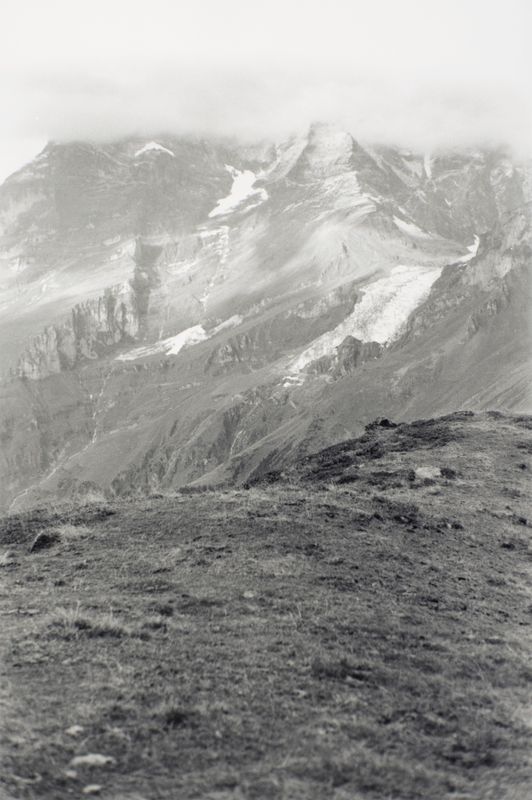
6, 67, 529, 150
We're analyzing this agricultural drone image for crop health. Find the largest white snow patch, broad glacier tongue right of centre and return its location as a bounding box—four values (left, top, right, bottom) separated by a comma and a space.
291, 265, 442, 372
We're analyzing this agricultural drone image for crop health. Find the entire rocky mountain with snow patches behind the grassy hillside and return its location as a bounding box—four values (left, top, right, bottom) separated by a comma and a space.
0, 124, 532, 509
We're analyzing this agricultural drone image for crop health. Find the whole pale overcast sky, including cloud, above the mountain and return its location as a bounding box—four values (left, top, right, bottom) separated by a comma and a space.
0, 0, 532, 179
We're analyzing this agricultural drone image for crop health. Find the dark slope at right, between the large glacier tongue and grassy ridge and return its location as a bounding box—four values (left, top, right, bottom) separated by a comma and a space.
209, 206, 532, 482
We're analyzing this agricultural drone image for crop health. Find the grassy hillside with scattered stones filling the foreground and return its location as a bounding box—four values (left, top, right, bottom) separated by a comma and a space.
0, 413, 532, 800
